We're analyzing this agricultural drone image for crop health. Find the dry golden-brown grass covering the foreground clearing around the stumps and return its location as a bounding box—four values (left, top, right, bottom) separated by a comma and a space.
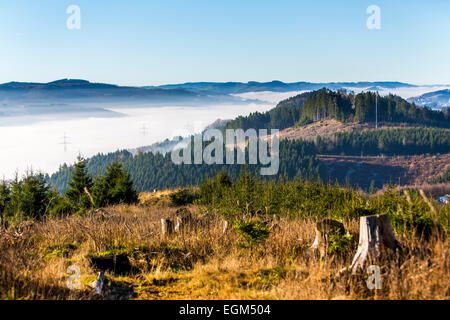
0, 202, 450, 300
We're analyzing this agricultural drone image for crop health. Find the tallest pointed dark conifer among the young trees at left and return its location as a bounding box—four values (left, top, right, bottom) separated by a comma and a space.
65, 156, 93, 210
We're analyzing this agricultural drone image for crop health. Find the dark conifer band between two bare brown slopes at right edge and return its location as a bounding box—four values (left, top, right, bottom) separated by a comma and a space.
316, 128, 450, 156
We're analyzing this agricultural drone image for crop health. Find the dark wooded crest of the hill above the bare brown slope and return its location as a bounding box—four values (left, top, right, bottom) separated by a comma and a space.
226, 88, 450, 130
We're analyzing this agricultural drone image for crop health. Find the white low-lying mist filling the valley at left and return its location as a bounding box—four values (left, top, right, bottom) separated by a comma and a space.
0, 103, 274, 179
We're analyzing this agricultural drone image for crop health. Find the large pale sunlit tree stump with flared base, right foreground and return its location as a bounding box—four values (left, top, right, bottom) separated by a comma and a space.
349, 214, 401, 273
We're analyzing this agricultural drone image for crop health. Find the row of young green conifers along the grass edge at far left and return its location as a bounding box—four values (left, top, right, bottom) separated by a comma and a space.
0, 158, 138, 223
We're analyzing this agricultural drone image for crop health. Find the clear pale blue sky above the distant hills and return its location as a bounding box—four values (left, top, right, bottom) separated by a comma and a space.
0, 0, 450, 85
